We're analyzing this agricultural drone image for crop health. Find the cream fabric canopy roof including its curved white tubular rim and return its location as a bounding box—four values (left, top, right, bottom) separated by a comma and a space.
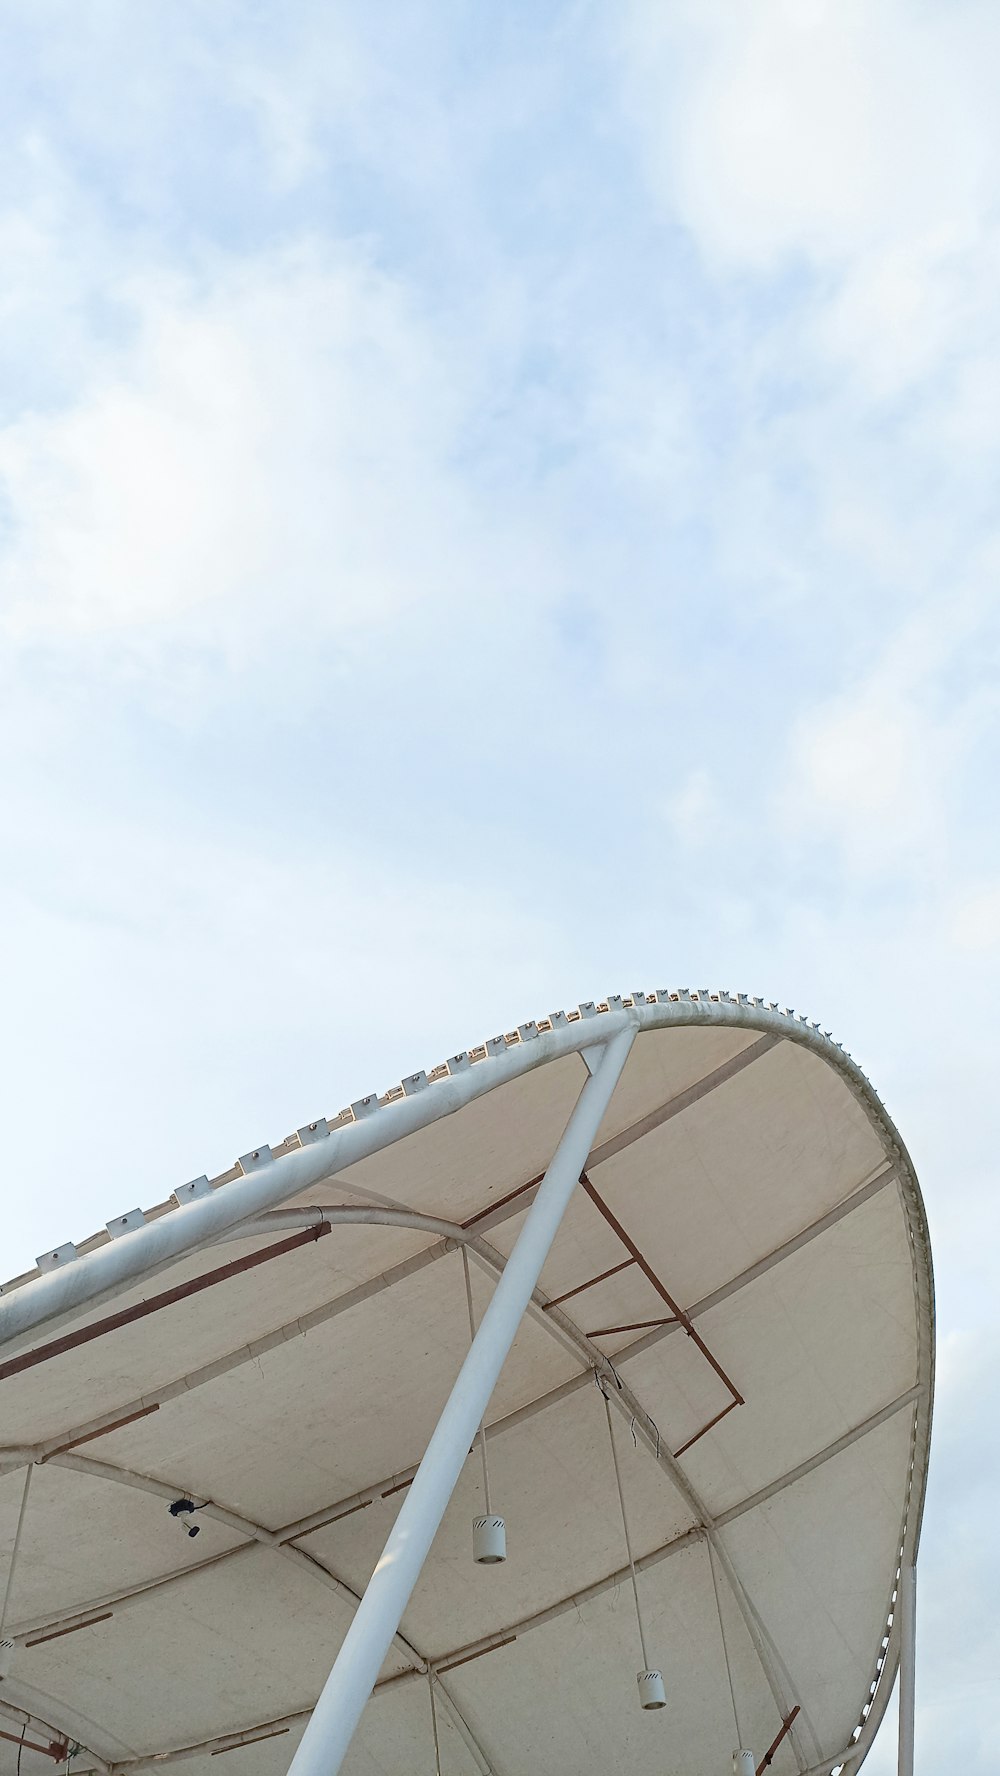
0, 993, 934, 1776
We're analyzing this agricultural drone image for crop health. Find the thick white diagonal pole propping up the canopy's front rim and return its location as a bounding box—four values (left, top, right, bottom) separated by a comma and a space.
288, 1027, 636, 1776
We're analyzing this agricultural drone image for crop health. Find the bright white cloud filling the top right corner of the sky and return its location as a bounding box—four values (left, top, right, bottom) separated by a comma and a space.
622, 0, 1000, 426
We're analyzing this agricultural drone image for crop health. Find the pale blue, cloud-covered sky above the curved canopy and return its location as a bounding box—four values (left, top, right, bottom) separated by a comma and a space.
0, 0, 1000, 1776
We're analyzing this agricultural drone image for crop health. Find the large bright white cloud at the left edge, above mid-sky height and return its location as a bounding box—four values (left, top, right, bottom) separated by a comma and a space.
0, 247, 525, 655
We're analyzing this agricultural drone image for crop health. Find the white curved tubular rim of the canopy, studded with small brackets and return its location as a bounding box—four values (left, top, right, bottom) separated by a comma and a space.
0, 987, 934, 1776
